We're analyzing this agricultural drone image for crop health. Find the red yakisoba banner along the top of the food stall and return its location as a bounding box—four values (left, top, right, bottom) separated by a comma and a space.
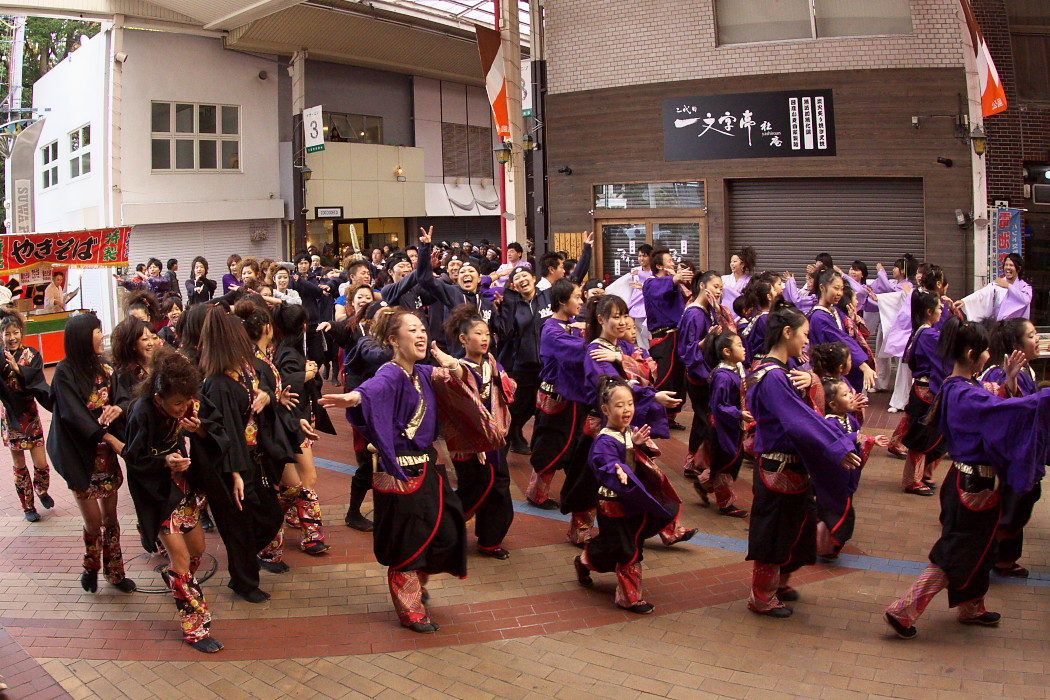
0, 226, 131, 274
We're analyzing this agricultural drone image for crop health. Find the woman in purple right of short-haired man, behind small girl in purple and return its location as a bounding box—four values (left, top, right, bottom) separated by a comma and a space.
678, 271, 736, 479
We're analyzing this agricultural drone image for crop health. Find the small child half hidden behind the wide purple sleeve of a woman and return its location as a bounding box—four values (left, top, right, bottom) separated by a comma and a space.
817, 377, 889, 561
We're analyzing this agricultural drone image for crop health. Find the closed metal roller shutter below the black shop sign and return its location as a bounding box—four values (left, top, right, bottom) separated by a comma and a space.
727, 178, 926, 277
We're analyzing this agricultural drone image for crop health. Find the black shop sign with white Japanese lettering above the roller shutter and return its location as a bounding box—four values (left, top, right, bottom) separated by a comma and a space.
664, 90, 835, 161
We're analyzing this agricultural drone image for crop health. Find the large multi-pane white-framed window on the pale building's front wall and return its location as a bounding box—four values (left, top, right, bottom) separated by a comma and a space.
150, 102, 240, 172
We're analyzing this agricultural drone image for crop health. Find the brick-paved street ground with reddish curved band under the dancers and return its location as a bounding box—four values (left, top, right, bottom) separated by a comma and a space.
0, 384, 1050, 699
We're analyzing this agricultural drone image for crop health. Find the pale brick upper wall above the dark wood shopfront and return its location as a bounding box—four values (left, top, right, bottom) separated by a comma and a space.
546, 0, 963, 93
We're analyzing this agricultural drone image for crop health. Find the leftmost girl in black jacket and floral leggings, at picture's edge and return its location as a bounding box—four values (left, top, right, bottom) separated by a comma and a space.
0, 312, 55, 523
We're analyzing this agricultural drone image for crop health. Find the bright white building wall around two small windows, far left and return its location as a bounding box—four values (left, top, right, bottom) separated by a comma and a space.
33, 33, 109, 233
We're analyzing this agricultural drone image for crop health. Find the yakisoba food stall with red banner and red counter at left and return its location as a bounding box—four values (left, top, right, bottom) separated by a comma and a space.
0, 227, 131, 364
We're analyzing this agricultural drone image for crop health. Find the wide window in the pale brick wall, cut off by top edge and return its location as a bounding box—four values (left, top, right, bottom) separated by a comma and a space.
715, 0, 911, 44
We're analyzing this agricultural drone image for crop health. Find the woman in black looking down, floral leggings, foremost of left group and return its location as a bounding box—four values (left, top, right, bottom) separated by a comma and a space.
124, 347, 223, 654
